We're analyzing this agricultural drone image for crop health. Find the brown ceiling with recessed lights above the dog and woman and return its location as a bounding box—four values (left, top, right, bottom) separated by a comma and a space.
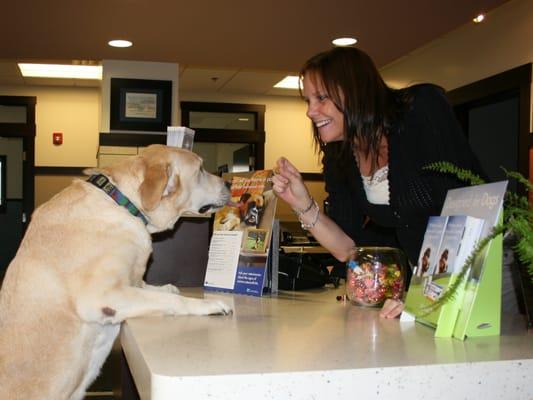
0, 0, 506, 95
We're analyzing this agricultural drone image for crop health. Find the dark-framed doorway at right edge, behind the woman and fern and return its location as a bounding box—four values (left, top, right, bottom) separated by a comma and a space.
448, 63, 533, 328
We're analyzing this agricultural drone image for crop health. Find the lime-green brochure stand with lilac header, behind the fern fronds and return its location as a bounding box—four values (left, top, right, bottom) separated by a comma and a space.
402, 181, 507, 340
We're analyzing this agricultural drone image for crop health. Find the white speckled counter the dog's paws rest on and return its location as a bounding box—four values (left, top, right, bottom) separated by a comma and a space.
121, 289, 533, 400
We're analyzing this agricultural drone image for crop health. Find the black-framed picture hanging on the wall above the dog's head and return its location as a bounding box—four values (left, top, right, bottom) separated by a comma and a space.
109, 78, 172, 132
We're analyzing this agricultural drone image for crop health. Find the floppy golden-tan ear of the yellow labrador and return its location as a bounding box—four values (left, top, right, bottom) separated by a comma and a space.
139, 163, 179, 211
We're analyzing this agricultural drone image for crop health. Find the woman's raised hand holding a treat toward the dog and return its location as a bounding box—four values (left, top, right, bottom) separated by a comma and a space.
272, 157, 312, 210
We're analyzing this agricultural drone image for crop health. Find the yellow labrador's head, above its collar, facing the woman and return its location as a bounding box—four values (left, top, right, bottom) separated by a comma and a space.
87, 145, 230, 232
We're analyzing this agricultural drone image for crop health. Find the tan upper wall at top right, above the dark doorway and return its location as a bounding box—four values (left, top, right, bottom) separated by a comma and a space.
381, 0, 533, 133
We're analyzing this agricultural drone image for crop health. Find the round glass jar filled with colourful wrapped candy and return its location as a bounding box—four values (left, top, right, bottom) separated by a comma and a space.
346, 247, 407, 307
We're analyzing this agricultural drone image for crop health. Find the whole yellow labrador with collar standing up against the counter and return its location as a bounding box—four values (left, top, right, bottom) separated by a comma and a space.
0, 145, 231, 400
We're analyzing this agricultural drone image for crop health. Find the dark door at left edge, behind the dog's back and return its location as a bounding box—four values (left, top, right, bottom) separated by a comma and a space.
0, 96, 36, 280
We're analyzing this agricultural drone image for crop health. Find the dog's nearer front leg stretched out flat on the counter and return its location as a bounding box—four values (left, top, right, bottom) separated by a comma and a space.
78, 287, 232, 324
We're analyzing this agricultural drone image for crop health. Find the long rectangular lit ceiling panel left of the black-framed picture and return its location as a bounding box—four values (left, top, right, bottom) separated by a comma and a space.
18, 63, 102, 80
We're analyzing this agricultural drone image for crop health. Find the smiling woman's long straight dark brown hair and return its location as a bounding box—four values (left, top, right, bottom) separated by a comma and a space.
300, 47, 408, 170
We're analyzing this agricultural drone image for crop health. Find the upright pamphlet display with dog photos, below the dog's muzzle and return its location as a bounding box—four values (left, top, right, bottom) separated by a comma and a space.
204, 170, 277, 296
